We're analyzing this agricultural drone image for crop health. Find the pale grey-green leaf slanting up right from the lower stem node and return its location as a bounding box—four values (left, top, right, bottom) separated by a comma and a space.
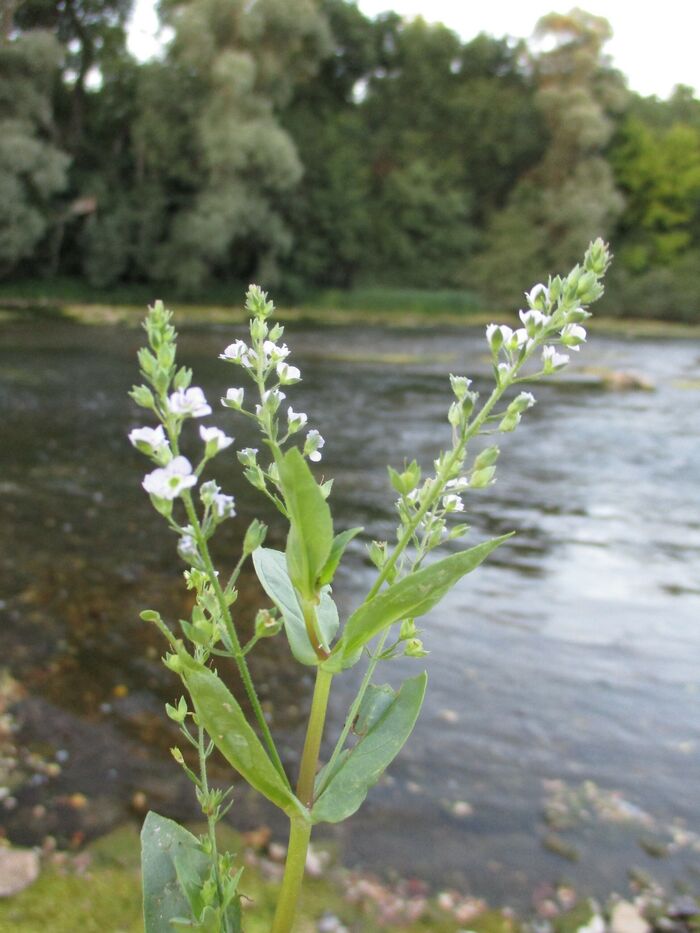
311, 673, 428, 823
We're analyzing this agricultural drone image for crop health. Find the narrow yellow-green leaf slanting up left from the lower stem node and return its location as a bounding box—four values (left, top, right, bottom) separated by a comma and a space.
179, 654, 304, 816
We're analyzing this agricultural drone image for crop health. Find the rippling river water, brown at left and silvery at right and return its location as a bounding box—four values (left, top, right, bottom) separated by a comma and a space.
0, 321, 700, 904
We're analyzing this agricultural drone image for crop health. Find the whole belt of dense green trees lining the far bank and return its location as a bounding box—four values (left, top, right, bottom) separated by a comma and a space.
0, 0, 700, 319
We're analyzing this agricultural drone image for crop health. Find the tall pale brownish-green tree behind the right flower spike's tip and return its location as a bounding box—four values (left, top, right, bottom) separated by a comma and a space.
474, 9, 625, 301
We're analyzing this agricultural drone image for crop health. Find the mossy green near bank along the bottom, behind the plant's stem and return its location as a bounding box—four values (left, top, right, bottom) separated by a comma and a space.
0, 827, 518, 933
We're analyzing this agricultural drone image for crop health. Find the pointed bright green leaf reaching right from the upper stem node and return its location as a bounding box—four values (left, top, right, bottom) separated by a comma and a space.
332, 534, 511, 658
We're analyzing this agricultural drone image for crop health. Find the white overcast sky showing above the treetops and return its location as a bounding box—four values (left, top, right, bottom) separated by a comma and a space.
129, 0, 700, 98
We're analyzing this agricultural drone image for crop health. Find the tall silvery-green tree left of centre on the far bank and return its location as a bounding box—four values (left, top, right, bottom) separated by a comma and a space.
151, 0, 328, 291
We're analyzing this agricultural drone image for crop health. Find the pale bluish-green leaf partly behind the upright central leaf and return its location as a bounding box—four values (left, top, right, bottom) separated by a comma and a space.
253, 547, 340, 664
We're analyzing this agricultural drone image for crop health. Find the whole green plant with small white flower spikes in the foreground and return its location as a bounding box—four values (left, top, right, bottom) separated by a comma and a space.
129, 240, 610, 933
